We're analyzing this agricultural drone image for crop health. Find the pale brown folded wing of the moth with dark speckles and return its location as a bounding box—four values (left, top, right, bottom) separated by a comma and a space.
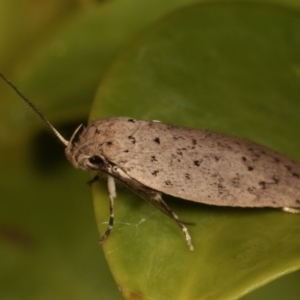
113, 121, 300, 207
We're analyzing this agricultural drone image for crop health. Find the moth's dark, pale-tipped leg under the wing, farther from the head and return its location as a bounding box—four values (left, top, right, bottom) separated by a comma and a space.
147, 193, 194, 251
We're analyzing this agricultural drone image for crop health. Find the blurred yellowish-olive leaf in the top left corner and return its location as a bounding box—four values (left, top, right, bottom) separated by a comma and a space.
0, 0, 82, 74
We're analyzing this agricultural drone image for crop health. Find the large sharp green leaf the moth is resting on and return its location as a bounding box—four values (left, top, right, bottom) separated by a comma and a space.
91, 3, 300, 300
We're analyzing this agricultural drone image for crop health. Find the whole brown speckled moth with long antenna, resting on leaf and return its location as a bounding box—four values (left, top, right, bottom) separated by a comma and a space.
0, 73, 300, 250
